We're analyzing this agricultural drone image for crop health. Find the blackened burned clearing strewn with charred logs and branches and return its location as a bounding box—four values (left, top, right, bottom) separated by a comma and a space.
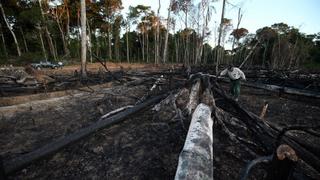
0, 66, 320, 179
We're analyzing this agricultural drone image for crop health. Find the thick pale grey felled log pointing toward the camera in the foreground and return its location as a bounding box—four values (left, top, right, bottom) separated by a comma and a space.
175, 103, 213, 180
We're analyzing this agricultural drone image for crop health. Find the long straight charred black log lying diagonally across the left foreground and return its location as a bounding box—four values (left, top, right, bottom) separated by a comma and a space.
3, 94, 166, 175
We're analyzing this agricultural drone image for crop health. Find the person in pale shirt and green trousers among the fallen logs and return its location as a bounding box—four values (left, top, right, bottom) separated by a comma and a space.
220, 65, 246, 101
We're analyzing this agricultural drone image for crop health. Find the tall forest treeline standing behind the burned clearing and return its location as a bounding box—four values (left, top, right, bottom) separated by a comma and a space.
0, 0, 320, 69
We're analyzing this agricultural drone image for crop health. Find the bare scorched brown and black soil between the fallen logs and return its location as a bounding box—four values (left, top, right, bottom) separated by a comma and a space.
0, 64, 320, 179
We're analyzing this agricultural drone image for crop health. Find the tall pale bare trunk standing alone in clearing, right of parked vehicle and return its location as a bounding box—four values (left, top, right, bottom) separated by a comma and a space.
81, 0, 87, 78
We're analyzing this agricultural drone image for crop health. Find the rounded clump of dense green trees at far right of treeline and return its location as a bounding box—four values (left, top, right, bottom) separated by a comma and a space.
237, 23, 320, 69
